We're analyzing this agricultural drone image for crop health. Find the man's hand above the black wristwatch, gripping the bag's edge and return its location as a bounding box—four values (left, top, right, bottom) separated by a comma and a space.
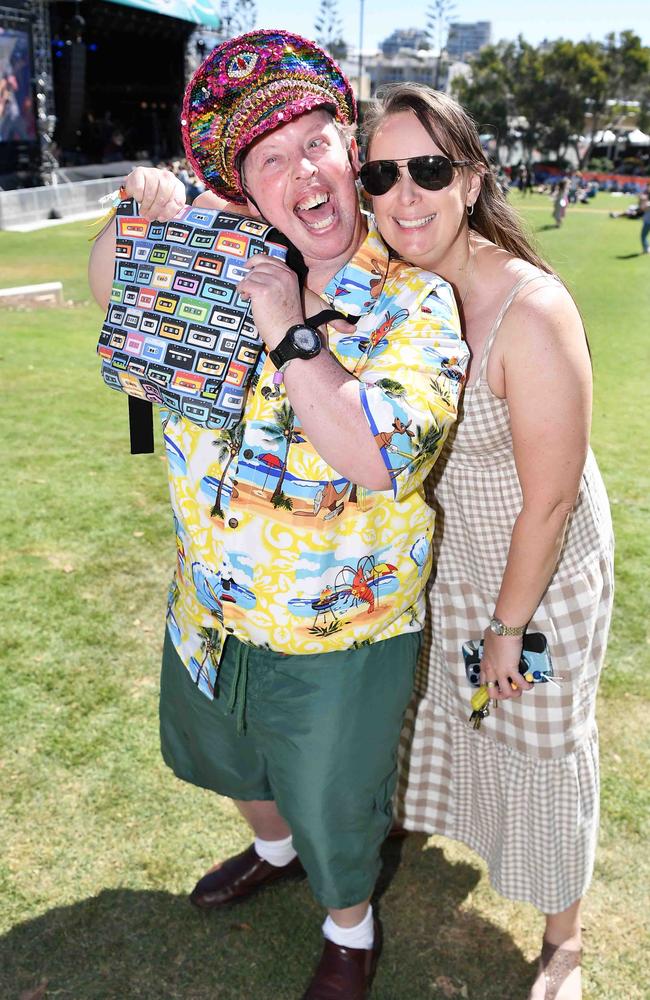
237, 254, 305, 351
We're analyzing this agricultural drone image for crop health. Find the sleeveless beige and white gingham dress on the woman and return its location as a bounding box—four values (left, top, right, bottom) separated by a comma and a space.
397, 275, 613, 913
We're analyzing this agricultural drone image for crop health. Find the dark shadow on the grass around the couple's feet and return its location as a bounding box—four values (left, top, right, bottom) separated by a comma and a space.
0, 835, 532, 1000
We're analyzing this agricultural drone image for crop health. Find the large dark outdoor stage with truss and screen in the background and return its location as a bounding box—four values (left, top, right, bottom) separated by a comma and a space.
0, 0, 220, 190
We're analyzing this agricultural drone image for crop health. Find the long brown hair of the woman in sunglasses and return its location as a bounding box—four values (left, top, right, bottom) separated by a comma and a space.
363, 83, 554, 274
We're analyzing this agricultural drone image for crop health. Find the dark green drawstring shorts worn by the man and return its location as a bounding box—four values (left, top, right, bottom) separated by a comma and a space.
160, 632, 421, 909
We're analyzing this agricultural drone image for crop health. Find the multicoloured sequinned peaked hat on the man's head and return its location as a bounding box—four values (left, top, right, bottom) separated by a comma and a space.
181, 31, 357, 202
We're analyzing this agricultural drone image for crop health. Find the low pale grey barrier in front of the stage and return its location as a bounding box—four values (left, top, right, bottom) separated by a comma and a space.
0, 177, 120, 229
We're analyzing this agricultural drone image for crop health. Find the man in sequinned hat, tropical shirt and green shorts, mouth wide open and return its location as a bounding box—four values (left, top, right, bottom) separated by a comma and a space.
91, 31, 467, 1000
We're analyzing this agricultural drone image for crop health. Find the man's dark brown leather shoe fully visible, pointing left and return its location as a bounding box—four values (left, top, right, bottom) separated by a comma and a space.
190, 844, 305, 910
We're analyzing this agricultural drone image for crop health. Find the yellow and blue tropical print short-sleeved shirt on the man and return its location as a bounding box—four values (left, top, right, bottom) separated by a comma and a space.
163, 228, 468, 697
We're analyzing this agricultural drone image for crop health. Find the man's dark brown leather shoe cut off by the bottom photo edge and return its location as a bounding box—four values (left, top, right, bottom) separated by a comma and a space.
302, 920, 381, 1000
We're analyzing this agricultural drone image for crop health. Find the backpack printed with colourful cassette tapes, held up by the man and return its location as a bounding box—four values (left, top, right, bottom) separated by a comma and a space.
97, 200, 287, 430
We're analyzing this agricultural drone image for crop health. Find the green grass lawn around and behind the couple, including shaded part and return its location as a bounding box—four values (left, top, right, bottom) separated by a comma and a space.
0, 194, 650, 1000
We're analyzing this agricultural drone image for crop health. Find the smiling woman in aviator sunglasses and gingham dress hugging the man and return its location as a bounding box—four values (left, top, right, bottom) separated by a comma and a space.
361, 84, 613, 1000
